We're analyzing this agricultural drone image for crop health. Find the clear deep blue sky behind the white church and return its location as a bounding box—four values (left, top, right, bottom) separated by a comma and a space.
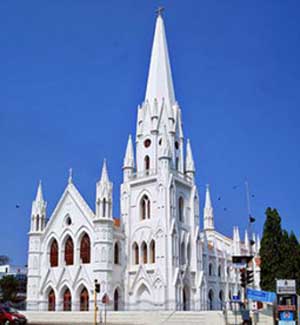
0, 0, 300, 264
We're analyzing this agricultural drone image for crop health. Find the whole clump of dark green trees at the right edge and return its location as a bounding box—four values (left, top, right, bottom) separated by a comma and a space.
260, 208, 300, 293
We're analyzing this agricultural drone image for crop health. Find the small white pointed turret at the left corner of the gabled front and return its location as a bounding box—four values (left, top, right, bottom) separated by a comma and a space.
30, 181, 47, 232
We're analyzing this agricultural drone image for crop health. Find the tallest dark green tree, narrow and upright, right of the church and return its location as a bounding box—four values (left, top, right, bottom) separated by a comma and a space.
260, 208, 286, 291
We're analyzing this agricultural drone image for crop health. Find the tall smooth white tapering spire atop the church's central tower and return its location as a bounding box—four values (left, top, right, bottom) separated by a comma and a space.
145, 10, 175, 105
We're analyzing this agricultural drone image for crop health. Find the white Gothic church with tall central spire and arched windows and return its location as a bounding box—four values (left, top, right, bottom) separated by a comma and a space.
27, 14, 260, 311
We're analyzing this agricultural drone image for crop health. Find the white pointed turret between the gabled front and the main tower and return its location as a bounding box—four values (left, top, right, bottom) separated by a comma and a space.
96, 160, 113, 219
